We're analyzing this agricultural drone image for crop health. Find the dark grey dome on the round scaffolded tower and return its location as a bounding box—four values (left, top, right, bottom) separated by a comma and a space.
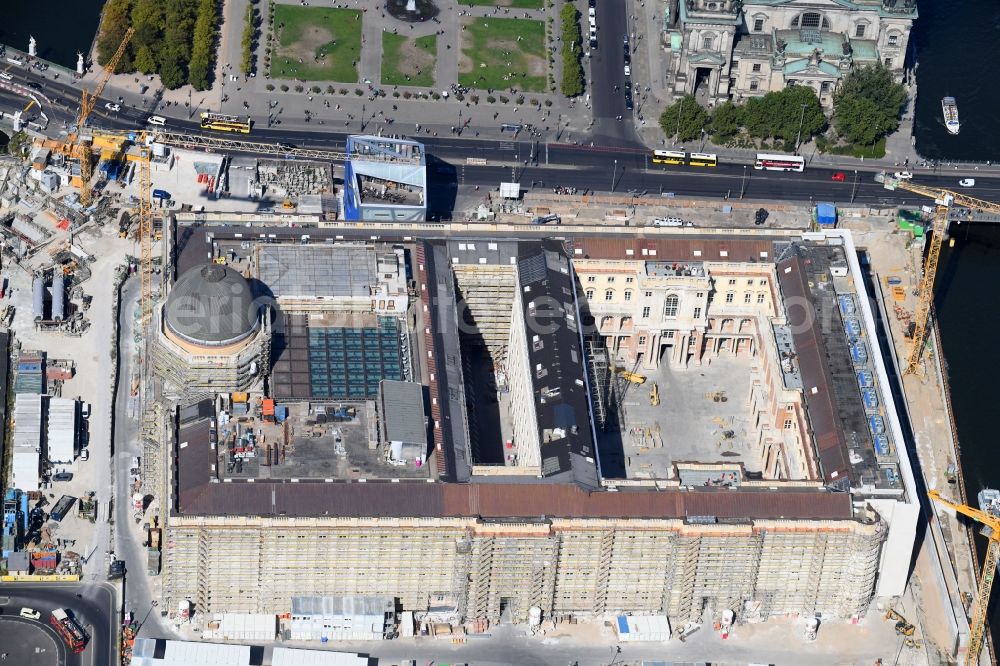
163, 264, 259, 347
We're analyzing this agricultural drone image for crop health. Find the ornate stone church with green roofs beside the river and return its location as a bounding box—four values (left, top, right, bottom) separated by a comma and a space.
663, 0, 917, 106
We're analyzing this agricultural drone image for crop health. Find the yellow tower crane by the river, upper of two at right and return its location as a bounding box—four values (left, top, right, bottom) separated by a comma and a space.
875, 171, 1000, 375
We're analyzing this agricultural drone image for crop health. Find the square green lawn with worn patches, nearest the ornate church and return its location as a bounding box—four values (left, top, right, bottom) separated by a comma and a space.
458, 17, 549, 92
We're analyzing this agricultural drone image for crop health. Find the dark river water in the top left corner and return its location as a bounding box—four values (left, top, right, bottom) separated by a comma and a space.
0, 0, 104, 69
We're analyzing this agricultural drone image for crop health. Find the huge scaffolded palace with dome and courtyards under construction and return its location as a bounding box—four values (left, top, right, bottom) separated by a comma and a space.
154, 219, 918, 626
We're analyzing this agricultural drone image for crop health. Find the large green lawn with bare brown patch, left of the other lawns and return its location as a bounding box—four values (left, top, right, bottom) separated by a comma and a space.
271, 5, 361, 83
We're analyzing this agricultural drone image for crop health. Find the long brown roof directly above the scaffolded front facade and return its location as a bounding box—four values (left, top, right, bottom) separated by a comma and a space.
174, 434, 853, 520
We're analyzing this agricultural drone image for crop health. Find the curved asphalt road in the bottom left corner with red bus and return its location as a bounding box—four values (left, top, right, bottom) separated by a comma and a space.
0, 583, 118, 666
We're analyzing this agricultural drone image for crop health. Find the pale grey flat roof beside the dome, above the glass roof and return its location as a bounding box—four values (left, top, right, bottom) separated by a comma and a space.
256, 244, 378, 298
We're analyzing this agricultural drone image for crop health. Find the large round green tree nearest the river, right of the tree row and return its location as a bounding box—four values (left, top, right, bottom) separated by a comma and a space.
833, 65, 906, 145
